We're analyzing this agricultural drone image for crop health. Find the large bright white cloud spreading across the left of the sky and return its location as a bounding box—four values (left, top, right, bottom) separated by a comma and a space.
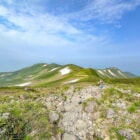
0, 2, 110, 48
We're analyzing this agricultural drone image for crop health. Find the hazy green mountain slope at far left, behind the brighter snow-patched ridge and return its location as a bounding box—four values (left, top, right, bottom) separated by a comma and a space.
0, 63, 60, 86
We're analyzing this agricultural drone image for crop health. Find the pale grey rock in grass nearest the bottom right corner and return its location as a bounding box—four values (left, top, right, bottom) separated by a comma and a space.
119, 129, 133, 140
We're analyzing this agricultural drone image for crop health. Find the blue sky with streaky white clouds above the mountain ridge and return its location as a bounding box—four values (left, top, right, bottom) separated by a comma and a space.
0, 0, 140, 75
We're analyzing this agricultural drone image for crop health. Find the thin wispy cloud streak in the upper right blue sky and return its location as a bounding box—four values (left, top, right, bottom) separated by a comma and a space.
66, 0, 140, 23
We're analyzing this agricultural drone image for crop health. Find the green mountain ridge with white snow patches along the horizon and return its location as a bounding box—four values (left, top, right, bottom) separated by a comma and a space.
0, 63, 135, 87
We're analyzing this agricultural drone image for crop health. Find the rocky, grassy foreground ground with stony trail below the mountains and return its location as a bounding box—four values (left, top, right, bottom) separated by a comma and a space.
0, 85, 140, 140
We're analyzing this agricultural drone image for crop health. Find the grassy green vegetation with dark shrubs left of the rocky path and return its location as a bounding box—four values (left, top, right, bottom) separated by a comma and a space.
0, 88, 63, 140
